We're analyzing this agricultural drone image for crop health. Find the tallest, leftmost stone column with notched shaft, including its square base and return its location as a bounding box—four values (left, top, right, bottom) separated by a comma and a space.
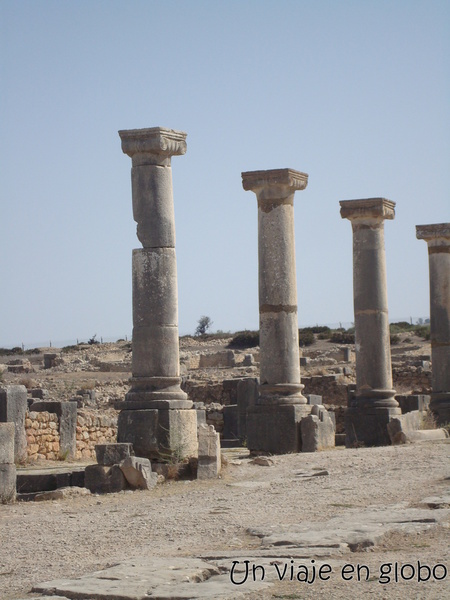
117, 127, 197, 459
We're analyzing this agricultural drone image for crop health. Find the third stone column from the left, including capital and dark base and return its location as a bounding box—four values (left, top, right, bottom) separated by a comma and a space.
340, 198, 401, 446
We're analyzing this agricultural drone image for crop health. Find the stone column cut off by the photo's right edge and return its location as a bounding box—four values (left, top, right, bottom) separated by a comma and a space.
416, 223, 450, 425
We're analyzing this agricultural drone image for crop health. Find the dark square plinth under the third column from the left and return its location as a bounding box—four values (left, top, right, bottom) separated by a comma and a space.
345, 406, 402, 448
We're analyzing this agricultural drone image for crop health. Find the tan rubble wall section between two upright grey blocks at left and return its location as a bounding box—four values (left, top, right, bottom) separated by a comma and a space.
25, 411, 60, 460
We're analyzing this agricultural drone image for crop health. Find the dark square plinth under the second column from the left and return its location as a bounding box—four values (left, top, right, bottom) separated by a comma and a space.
247, 404, 311, 454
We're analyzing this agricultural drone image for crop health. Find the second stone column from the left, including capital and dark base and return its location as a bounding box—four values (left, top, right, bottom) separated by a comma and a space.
242, 169, 311, 454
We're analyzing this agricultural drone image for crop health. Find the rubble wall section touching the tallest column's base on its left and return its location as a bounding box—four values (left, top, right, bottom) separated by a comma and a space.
76, 411, 117, 459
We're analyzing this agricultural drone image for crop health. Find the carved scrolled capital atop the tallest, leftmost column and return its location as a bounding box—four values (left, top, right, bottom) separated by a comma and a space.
119, 127, 187, 166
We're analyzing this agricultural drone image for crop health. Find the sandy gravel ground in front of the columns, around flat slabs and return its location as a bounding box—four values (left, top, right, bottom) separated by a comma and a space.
0, 442, 450, 600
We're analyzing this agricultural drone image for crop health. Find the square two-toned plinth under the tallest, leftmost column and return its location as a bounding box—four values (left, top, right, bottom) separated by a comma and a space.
117, 402, 198, 462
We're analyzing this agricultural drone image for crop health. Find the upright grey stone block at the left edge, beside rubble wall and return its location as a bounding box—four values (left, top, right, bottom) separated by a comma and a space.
0, 385, 28, 462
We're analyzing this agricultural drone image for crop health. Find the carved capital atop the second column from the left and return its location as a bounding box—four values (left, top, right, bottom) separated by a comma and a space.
241, 169, 308, 200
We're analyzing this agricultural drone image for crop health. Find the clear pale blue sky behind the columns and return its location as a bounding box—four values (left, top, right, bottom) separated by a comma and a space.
0, 0, 450, 346
